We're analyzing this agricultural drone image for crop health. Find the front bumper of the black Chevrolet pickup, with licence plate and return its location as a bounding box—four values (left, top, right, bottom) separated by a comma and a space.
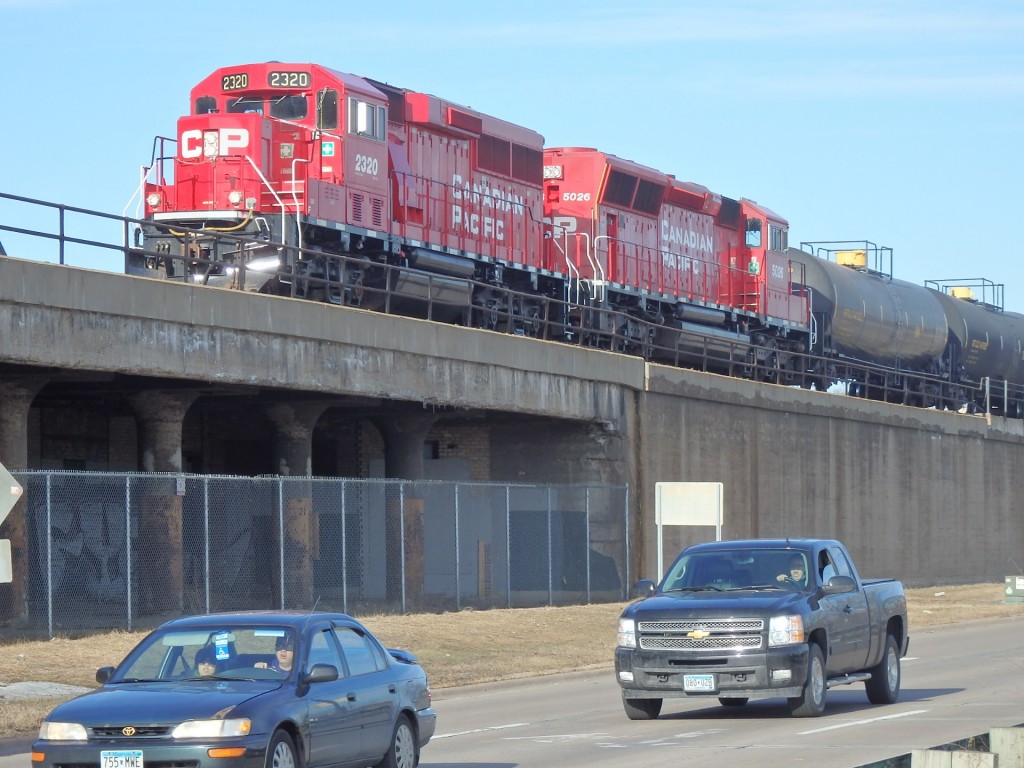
615, 644, 808, 698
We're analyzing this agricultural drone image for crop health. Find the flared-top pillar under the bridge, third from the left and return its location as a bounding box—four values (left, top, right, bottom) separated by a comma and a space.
266, 402, 327, 609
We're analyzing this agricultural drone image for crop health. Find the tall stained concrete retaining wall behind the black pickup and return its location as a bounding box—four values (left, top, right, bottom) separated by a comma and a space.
636, 366, 1024, 584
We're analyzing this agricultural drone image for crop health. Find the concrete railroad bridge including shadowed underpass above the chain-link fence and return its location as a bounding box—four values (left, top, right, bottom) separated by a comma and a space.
0, 257, 1024, 618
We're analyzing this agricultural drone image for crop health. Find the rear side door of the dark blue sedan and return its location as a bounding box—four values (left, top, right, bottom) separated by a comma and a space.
335, 625, 398, 760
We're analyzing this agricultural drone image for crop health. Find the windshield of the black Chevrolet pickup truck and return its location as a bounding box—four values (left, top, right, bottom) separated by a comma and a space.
662, 549, 809, 592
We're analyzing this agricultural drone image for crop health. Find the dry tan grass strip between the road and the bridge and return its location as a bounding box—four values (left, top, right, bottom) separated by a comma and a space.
0, 584, 1024, 737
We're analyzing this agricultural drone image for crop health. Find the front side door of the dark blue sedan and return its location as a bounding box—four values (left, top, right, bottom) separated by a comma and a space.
302, 627, 362, 768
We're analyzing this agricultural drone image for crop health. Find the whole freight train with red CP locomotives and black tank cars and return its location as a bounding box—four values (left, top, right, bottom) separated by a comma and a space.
127, 62, 1024, 418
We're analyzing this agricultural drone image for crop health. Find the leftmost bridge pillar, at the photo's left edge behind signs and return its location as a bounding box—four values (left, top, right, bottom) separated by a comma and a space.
0, 377, 46, 621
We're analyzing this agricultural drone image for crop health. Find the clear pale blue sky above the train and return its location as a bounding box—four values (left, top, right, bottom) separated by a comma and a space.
0, 0, 1024, 311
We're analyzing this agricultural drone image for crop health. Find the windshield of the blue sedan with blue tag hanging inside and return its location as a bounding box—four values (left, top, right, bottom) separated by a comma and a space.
109, 625, 295, 684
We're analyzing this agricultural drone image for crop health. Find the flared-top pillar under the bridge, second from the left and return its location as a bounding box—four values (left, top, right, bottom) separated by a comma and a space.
130, 390, 199, 613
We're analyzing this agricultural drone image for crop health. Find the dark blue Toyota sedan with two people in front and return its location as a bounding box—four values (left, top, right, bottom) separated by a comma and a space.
32, 611, 436, 768
